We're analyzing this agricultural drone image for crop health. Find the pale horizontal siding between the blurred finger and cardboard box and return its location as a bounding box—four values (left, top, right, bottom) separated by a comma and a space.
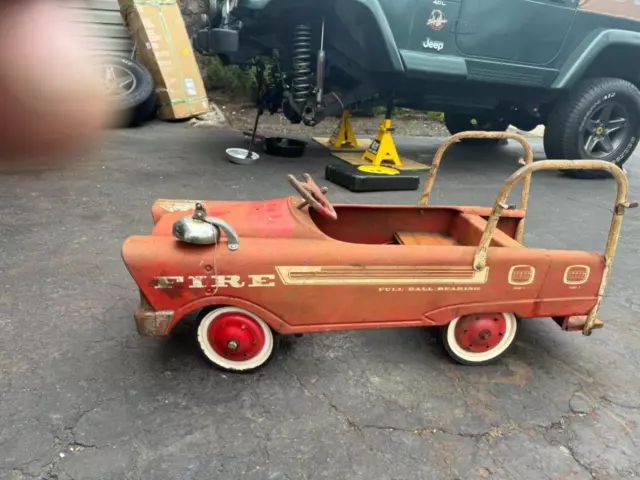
64, 0, 133, 57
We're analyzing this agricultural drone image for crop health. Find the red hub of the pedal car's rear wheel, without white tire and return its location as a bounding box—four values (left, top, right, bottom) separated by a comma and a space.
455, 313, 507, 353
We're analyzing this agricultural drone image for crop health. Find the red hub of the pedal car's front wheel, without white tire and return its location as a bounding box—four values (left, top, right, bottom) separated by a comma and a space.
207, 312, 265, 361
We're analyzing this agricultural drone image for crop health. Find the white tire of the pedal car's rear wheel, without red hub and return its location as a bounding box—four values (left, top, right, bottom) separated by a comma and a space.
442, 313, 518, 366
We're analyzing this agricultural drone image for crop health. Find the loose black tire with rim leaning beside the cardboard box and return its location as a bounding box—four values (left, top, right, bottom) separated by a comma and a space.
98, 55, 156, 127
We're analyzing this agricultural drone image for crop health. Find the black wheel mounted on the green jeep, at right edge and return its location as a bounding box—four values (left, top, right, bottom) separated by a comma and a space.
544, 78, 640, 178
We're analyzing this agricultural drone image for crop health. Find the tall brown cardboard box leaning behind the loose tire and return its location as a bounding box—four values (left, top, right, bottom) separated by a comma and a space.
118, 0, 209, 120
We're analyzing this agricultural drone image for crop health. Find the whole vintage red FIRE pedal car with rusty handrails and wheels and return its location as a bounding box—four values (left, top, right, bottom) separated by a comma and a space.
122, 132, 637, 371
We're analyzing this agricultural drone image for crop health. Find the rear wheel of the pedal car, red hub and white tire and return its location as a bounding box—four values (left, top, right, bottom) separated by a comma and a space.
442, 313, 518, 365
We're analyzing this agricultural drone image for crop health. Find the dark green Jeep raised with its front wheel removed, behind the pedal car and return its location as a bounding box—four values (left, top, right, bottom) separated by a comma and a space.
193, 0, 640, 175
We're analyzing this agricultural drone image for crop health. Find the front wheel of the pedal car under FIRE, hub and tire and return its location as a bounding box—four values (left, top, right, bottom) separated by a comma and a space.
198, 307, 276, 372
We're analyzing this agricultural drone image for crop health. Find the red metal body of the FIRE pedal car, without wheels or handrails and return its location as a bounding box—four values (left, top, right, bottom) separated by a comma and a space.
123, 198, 604, 334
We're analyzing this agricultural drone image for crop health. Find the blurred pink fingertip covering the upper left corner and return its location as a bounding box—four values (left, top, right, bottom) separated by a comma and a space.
0, 0, 110, 162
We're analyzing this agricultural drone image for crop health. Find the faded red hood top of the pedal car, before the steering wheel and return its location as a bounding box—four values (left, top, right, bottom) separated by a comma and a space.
151, 197, 326, 239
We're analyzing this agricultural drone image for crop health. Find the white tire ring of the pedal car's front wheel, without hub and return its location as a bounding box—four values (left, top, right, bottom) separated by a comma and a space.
198, 307, 276, 373
